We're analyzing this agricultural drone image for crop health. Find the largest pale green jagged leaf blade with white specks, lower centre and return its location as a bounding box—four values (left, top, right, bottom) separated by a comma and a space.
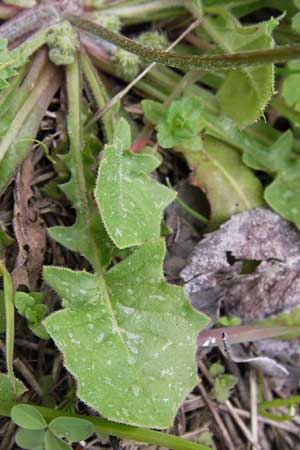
44, 240, 208, 428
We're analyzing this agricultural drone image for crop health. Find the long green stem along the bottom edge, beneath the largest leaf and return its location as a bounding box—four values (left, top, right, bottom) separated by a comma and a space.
0, 404, 211, 450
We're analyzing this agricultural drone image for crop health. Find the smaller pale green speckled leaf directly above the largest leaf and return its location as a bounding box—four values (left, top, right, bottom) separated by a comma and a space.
95, 119, 175, 248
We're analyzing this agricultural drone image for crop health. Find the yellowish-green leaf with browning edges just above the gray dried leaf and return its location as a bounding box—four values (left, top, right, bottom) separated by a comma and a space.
183, 136, 264, 227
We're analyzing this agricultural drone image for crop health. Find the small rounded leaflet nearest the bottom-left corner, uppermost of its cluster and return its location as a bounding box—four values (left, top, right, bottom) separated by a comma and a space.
11, 405, 47, 430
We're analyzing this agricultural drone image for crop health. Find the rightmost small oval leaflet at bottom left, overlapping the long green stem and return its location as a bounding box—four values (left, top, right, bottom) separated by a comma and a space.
49, 417, 95, 442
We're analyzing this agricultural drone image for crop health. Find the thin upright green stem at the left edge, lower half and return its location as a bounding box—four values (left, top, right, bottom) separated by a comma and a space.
0, 261, 16, 392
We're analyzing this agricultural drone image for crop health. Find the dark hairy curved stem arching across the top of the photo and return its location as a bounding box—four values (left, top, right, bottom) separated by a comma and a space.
70, 16, 300, 70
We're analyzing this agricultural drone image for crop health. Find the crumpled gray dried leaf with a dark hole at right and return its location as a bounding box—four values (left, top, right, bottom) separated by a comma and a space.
181, 208, 300, 372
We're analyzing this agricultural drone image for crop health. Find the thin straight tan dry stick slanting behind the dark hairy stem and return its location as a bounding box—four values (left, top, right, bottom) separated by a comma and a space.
86, 18, 201, 128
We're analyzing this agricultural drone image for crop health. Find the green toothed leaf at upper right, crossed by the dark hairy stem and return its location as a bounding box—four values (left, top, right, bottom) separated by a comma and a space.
203, 13, 278, 126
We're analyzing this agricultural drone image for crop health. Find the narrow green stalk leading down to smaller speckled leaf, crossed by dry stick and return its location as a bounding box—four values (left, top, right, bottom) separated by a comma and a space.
80, 50, 114, 142
